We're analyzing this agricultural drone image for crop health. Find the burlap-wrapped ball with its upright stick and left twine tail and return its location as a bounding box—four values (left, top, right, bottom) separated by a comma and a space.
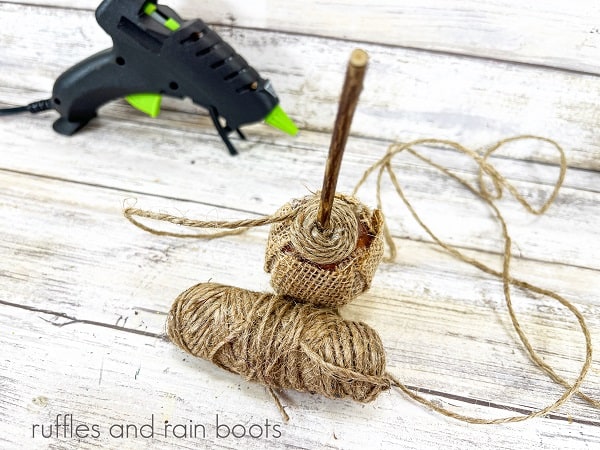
125, 49, 384, 306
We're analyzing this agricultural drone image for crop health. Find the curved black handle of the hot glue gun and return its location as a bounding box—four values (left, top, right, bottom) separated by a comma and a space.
52, 49, 145, 136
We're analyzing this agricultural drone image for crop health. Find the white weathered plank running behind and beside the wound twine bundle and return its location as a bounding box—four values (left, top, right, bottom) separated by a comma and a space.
0, 173, 600, 420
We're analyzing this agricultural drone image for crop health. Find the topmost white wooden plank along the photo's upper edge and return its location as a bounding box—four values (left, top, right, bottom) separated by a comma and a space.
3, 0, 600, 73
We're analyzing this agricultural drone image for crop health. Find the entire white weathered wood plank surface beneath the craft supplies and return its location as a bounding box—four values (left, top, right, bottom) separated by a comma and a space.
0, 0, 600, 449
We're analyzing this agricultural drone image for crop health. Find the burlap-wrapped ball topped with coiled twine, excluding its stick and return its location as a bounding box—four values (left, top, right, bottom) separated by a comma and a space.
265, 193, 384, 306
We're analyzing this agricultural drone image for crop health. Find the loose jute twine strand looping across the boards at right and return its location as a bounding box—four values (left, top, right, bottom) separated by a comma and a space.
353, 135, 600, 424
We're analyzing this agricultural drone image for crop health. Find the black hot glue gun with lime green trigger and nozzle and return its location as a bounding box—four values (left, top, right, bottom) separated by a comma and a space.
0, 0, 297, 155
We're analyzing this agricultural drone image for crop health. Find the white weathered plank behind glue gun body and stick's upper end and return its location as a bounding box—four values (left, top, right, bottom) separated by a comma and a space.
0, 5, 600, 170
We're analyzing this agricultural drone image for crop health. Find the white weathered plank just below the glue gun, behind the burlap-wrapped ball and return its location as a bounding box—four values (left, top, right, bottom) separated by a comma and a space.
0, 107, 600, 269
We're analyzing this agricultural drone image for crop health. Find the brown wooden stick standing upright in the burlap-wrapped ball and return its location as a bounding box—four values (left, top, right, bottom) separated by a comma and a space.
317, 49, 369, 229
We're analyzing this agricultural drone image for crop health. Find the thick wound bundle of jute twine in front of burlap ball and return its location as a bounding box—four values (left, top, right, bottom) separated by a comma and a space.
167, 283, 390, 422
